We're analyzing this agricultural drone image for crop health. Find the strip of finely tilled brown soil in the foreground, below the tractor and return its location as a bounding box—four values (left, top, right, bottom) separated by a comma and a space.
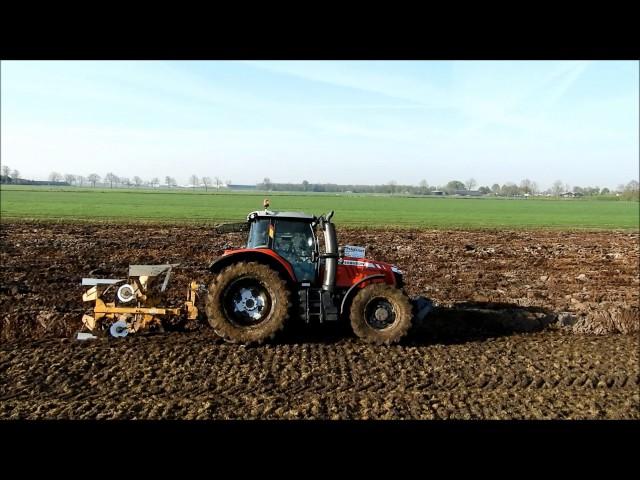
0, 332, 640, 419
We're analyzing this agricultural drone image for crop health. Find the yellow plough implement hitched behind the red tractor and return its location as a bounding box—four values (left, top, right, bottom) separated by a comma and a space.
82, 264, 201, 337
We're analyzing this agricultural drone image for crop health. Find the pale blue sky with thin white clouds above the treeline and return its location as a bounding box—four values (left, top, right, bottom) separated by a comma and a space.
0, 61, 640, 188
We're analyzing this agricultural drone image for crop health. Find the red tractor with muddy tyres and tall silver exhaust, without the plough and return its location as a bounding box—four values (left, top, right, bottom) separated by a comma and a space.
206, 200, 431, 344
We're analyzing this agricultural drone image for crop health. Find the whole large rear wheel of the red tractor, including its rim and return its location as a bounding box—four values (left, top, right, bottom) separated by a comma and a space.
206, 262, 290, 344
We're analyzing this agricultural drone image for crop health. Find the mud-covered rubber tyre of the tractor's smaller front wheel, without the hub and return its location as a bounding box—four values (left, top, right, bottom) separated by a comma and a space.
349, 283, 413, 345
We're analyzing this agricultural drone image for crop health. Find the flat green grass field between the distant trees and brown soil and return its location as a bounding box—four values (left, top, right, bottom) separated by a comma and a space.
0, 186, 640, 230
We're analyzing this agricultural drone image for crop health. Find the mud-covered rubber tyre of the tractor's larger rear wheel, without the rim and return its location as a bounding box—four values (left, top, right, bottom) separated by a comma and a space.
205, 262, 291, 345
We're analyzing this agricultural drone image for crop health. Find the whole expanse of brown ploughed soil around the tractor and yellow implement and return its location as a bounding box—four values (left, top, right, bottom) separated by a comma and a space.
0, 223, 640, 419
